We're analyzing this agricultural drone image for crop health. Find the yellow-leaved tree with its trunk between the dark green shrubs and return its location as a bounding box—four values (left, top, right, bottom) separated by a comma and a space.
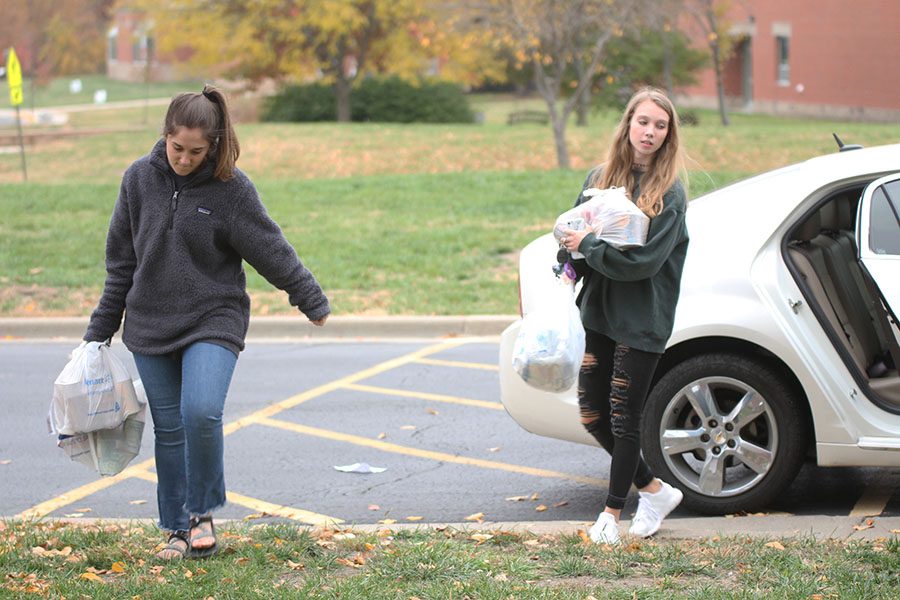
129, 0, 500, 121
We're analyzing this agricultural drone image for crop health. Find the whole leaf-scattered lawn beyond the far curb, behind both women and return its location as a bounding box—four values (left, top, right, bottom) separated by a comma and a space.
0, 96, 900, 316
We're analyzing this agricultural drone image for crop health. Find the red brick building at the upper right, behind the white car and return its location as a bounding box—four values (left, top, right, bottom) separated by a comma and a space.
680, 0, 900, 121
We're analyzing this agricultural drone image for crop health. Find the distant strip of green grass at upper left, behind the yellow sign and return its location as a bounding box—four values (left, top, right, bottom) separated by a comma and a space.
0, 75, 202, 110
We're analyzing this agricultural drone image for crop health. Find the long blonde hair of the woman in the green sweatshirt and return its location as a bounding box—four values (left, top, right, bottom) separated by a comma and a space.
591, 87, 687, 218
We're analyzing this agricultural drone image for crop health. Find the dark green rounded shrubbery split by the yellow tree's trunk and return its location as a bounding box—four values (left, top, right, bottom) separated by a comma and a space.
263, 77, 475, 123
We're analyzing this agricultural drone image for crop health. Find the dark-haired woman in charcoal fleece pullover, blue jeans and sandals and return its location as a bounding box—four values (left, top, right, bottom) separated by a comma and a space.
84, 86, 331, 560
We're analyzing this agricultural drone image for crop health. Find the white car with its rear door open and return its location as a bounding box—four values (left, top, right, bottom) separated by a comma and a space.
499, 144, 900, 513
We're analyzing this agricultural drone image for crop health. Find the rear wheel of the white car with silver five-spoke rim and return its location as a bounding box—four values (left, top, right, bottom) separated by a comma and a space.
642, 354, 808, 514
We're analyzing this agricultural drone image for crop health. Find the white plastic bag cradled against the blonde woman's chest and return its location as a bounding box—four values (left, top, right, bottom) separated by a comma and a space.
553, 187, 650, 258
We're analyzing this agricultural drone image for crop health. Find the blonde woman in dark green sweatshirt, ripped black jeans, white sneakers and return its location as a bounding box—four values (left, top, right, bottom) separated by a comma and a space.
561, 88, 688, 544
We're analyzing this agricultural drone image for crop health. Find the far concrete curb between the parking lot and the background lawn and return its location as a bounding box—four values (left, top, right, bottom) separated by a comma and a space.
0, 315, 518, 341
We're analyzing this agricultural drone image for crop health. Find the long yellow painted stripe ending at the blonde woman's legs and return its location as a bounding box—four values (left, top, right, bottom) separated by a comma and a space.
257, 417, 609, 487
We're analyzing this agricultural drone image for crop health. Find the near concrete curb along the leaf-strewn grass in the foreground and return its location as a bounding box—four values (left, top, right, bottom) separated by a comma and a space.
15, 515, 900, 541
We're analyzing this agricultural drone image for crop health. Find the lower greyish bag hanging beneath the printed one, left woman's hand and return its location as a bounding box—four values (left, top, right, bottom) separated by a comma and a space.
57, 379, 147, 476
